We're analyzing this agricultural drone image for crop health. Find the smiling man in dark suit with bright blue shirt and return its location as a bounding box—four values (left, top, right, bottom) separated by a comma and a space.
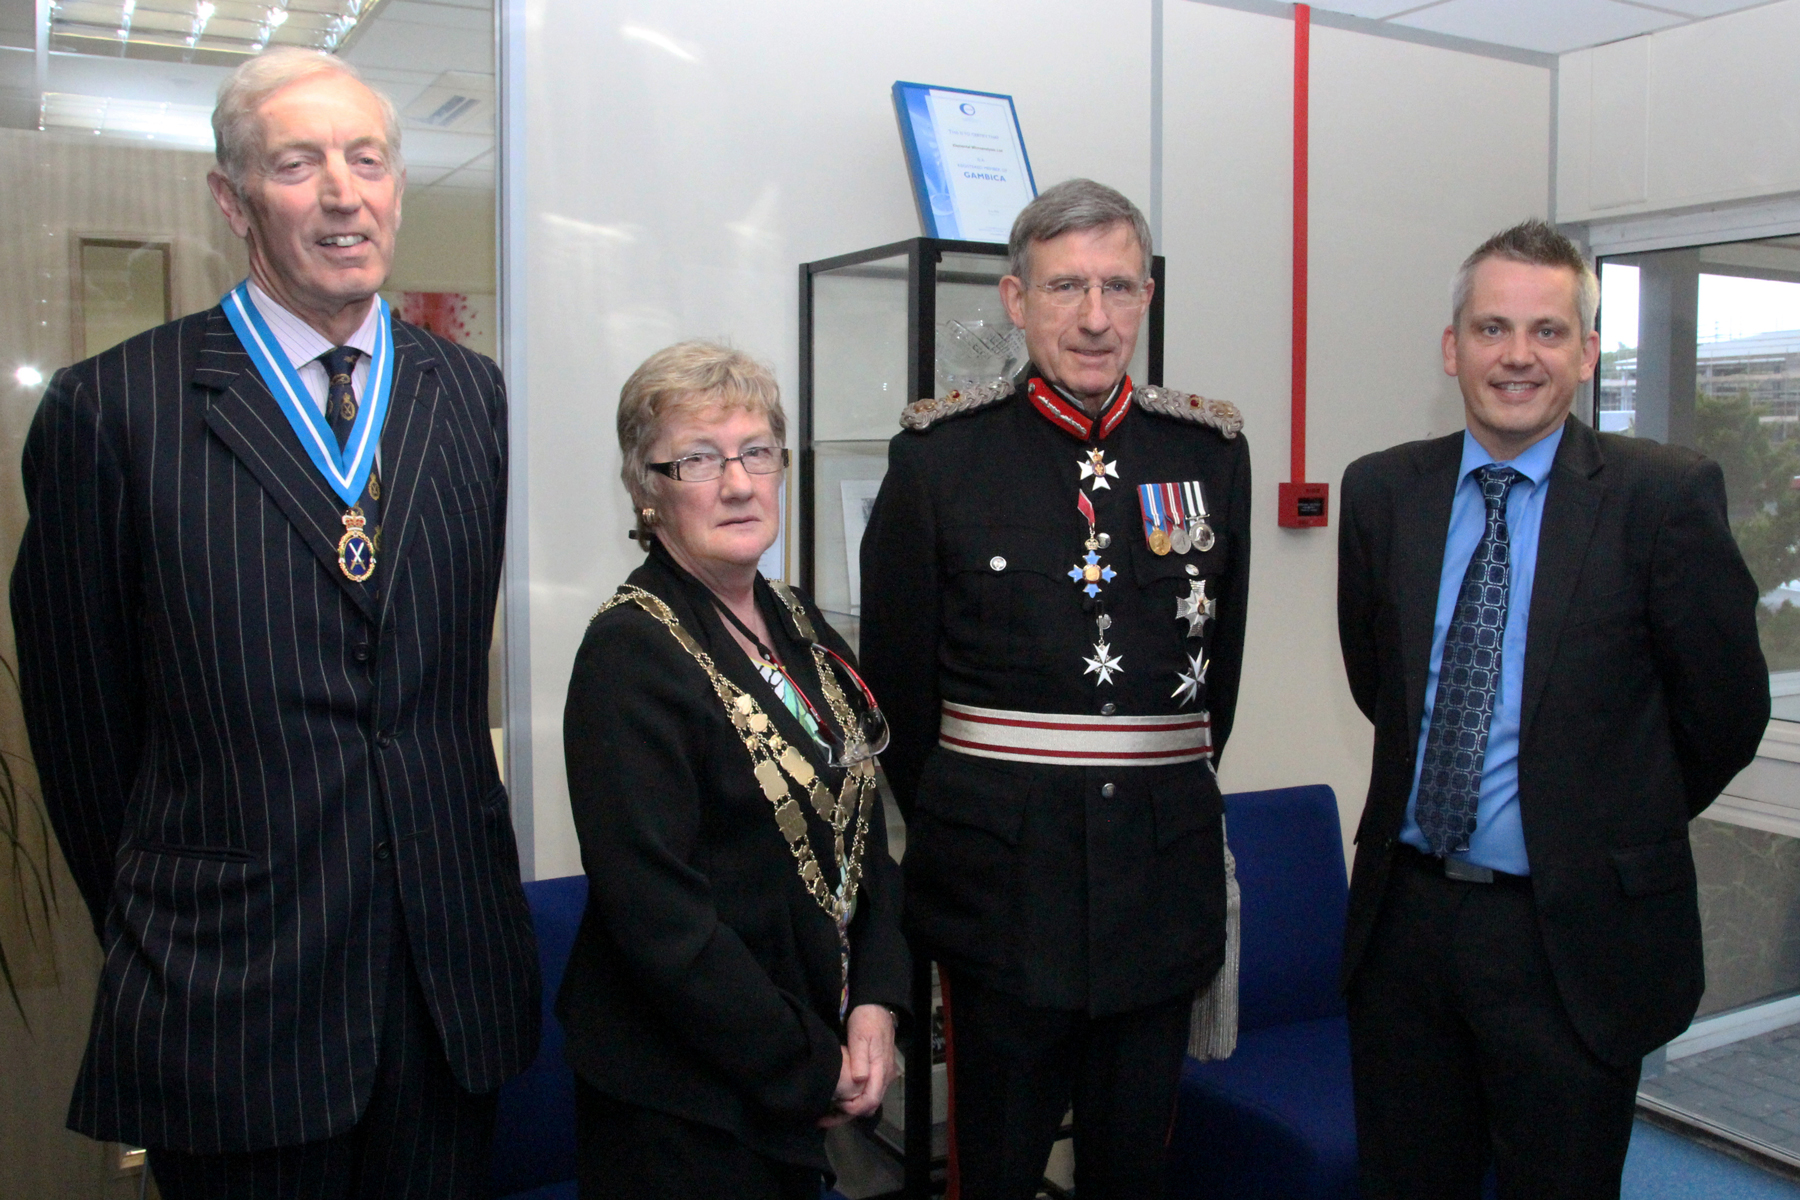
1337, 221, 1769, 1200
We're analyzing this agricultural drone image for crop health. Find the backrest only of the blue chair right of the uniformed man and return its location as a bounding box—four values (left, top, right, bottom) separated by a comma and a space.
1226, 784, 1350, 1031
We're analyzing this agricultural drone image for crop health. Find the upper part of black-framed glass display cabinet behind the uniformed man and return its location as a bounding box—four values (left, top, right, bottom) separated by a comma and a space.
796, 237, 1163, 648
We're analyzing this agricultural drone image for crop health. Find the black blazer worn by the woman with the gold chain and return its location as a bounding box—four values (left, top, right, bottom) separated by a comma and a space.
556, 545, 911, 1169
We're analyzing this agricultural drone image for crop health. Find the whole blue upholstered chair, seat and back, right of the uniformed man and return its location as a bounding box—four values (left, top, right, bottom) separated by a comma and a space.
1168, 786, 1357, 1200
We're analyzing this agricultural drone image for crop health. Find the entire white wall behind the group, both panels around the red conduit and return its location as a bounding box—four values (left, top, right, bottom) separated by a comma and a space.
511, 0, 1550, 876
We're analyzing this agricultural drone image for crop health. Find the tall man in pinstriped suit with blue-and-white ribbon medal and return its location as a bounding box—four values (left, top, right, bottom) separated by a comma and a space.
13, 50, 538, 1200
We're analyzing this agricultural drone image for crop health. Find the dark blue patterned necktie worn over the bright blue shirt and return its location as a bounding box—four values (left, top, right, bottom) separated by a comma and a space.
1413, 464, 1519, 858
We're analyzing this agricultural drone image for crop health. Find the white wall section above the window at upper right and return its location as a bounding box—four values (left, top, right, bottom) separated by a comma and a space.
1557, 0, 1800, 221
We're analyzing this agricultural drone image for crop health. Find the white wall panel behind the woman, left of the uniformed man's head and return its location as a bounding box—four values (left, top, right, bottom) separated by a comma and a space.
509, 0, 1150, 876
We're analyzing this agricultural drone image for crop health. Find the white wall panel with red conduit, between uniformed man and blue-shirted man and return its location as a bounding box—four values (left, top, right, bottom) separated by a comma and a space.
1163, 2, 1550, 859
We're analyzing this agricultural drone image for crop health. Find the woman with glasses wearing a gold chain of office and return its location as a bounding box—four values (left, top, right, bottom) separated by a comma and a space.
558, 342, 911, 1200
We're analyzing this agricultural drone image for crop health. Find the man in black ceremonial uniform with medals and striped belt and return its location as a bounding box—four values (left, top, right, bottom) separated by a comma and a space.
862, 180, 1249, 1200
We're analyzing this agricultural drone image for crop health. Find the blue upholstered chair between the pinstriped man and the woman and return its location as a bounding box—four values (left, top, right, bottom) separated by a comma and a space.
490, 874, 587, 1200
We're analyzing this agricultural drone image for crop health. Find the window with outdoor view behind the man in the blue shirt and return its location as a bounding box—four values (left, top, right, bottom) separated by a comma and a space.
1595, 237, 1800, 1166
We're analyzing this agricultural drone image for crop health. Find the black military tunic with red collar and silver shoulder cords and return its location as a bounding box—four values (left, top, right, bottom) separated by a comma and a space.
862, 367, 1251, 1016
